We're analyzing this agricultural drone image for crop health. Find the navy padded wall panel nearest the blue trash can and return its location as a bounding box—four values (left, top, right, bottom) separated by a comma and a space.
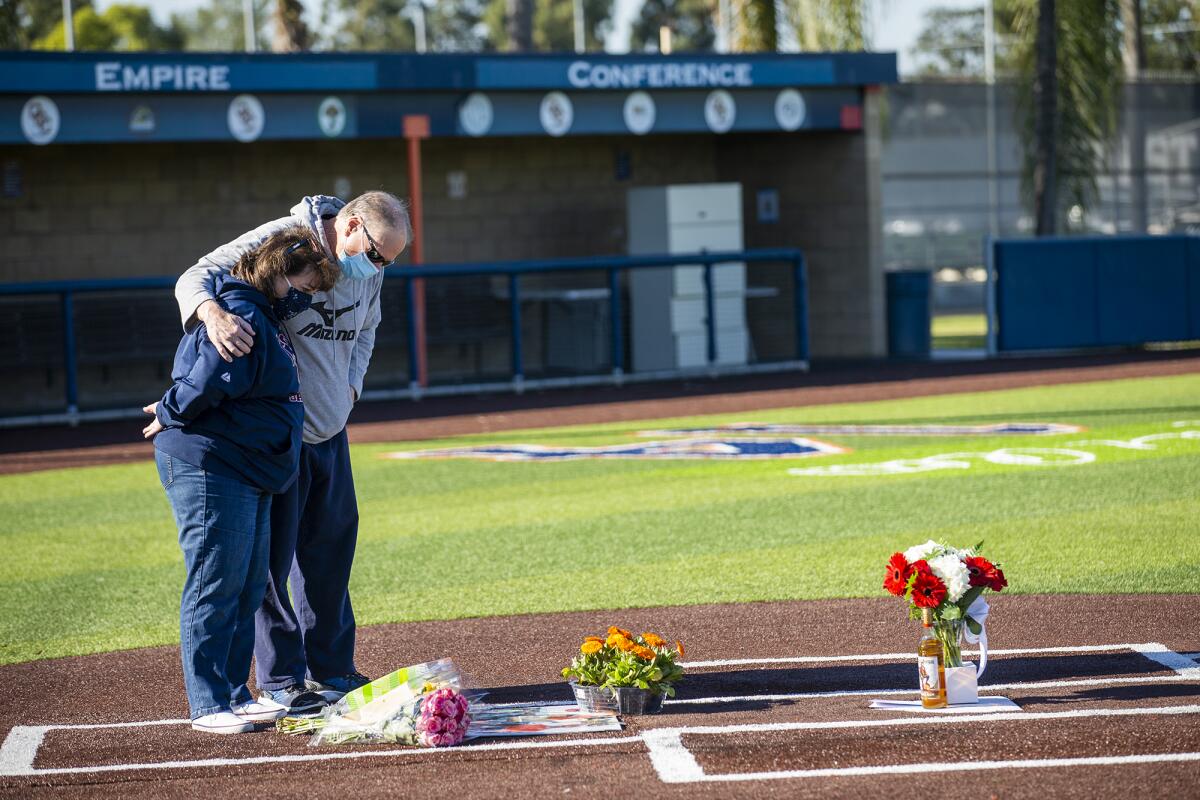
995, 240, 1098, 350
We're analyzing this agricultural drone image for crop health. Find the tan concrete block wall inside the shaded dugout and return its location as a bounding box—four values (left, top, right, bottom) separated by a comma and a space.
0, 132, 882, 367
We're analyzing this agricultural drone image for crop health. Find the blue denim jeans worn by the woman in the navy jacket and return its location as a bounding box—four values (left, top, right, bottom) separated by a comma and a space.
155, 451, 271, 720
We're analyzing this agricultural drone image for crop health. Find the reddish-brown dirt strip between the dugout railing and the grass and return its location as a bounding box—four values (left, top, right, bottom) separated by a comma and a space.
0, 350, 1200, 475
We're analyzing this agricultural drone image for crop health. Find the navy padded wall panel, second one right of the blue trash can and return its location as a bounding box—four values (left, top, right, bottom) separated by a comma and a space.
1094, 237, 1188, 344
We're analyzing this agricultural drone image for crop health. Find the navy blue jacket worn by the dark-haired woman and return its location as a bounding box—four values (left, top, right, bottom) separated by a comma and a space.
154, 276, 304, 494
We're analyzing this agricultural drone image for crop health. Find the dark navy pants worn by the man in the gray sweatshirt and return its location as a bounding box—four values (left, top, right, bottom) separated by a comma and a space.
254, 429, 359, 690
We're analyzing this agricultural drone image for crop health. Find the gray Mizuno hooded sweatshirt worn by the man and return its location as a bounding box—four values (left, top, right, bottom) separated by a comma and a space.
175, 194, 383, 444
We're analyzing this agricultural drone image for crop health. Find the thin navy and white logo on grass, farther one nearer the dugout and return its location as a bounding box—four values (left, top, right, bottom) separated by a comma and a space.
637, 422, 1084, 437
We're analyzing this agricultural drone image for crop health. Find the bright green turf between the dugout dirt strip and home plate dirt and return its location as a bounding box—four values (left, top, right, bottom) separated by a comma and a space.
0, 375, 1200, 663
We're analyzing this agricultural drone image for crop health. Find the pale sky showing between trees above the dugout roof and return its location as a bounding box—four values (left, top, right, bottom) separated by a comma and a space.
88, 0, 983, 74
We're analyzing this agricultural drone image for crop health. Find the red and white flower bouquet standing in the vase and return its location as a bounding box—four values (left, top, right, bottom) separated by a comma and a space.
883, 540, 1008, 674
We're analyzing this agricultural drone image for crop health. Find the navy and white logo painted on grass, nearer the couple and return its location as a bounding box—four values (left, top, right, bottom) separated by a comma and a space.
385, 438, 847, 462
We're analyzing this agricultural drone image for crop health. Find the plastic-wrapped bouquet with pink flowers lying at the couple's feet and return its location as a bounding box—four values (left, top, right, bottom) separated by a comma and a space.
276, 658, 470, 747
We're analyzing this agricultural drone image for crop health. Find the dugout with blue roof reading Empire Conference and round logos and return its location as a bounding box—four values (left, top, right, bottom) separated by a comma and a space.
0, 53, 896, 415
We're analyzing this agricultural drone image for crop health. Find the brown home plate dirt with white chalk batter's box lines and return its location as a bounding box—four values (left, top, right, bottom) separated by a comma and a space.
0, 596, 1200, 800
